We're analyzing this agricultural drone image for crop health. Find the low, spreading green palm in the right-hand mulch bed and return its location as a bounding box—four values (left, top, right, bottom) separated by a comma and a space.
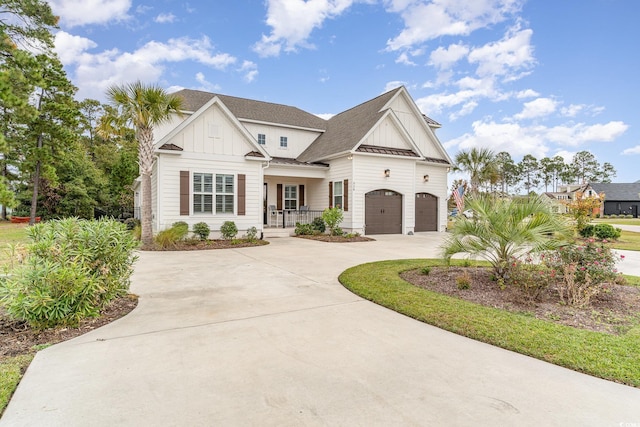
442, 194, 573, 278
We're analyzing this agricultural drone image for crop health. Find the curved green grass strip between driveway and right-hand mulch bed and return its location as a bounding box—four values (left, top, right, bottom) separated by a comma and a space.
339, 259, 640, 387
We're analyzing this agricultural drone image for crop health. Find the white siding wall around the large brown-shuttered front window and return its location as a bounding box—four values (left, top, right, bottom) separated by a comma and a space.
158, 156, 262, 237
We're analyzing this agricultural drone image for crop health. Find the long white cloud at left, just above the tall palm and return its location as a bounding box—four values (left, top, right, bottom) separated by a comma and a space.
56, 31, 237, 99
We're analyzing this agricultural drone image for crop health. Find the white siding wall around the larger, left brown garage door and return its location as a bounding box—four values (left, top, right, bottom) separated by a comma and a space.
350, 154, 416, 234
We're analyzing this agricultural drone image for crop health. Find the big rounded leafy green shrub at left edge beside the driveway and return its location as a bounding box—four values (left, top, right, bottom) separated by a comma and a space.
0, 218, 138, 329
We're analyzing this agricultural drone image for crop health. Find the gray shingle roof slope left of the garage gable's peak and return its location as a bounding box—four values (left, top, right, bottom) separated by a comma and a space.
298, 88, 401, 162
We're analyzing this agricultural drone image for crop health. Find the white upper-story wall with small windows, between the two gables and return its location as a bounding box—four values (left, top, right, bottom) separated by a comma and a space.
242, 122, 321, 159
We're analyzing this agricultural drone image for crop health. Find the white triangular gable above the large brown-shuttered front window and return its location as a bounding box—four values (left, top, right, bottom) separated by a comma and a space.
156, 97, 268, 158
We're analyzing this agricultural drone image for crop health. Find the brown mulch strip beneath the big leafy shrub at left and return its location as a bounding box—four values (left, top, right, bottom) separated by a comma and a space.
0, 294, 138, 361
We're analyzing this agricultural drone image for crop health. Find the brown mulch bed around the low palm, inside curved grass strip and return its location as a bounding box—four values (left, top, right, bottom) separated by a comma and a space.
401, 267, 640, 335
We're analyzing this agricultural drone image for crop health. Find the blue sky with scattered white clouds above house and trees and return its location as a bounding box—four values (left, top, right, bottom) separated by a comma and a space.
49, 0, 640, 186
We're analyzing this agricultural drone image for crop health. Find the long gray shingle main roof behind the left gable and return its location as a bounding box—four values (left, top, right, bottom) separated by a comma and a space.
175, 89, 327, 130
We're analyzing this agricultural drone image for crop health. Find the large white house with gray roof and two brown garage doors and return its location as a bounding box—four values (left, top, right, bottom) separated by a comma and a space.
134, 87, 452, 234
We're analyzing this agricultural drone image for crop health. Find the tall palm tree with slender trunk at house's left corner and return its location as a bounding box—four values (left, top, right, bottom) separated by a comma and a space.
101, 81, 182, 246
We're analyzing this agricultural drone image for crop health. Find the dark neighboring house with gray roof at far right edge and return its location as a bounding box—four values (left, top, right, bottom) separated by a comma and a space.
583, 182, 640, 218
